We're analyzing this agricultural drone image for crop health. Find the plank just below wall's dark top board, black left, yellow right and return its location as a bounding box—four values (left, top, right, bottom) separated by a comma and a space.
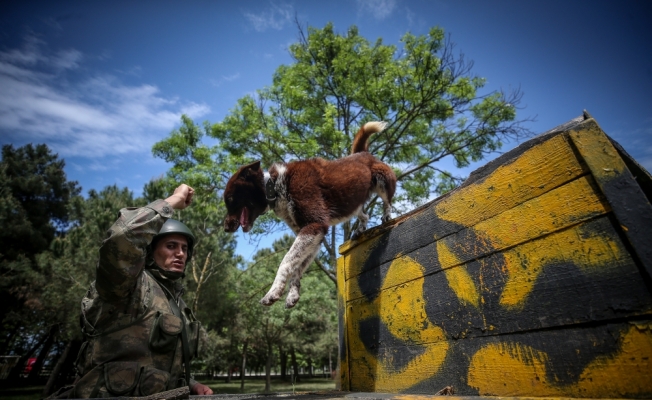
340, 135, 588, 279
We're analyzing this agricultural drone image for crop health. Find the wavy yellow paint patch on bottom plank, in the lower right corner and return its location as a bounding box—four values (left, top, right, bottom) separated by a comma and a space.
468, 323, 652, 398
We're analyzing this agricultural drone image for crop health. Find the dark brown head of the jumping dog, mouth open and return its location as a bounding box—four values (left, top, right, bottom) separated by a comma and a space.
224, 161, 267, 232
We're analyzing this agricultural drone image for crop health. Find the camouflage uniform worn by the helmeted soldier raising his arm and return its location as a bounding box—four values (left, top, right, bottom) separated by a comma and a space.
70, 200, 201, 398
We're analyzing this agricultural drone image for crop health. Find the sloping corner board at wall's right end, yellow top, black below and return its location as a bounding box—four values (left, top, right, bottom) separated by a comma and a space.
570, 119, 652, 282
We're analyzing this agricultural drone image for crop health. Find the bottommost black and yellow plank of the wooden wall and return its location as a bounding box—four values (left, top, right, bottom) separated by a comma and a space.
344, 320, 652, 398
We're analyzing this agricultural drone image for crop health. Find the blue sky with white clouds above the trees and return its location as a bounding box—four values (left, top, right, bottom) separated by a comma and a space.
0, 0, 652, 258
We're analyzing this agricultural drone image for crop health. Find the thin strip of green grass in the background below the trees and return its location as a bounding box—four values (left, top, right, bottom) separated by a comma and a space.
0, 378, 335, 400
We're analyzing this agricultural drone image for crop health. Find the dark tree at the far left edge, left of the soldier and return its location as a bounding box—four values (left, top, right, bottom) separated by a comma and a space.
0, 144, 81, 360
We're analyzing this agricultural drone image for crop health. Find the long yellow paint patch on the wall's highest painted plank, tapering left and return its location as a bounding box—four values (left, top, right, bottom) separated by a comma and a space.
434, 135, 587, 234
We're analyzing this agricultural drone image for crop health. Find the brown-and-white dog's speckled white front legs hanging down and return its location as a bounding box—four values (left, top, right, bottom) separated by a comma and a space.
260, 223, 328, 307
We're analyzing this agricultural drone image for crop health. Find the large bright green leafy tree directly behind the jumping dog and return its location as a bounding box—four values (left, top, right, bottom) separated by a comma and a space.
154, 23, 529, 280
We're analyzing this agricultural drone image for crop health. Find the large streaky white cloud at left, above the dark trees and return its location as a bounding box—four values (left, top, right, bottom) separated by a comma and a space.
0, 37, 210, 158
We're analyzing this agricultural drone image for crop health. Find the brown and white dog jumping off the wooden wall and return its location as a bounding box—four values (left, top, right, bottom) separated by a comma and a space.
224, 122, 396, 308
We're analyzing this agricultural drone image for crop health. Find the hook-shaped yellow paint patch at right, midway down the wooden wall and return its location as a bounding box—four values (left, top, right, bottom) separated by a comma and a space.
500, 222, 631, 310
